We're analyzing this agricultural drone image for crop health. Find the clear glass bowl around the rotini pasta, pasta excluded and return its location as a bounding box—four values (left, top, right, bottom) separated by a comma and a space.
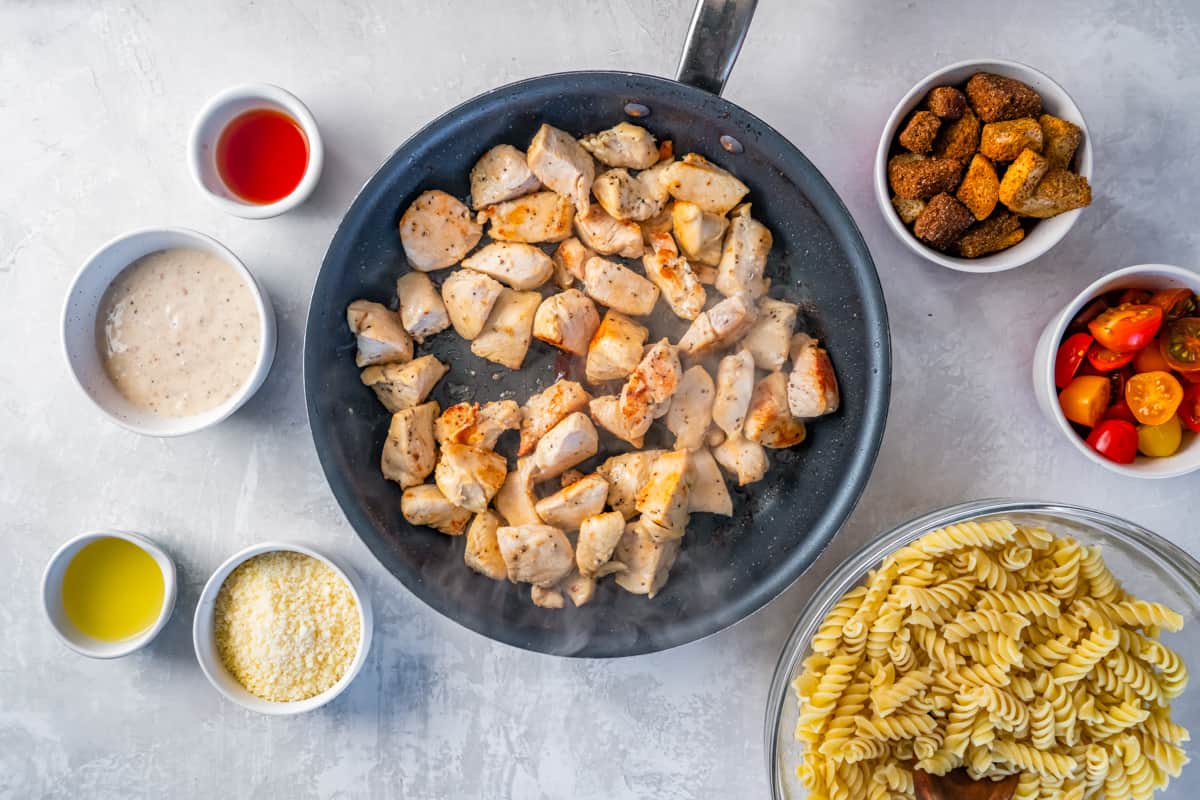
766, 500, 1200, 800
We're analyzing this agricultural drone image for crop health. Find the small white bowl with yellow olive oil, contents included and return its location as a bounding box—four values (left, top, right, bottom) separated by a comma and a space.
42, 530, 175, 658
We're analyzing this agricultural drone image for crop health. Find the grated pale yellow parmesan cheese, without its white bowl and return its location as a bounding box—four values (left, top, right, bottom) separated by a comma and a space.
214, 552, 362, 703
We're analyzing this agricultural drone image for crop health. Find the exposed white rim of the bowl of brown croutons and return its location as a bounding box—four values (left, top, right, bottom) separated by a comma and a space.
874, 58, 1093, 275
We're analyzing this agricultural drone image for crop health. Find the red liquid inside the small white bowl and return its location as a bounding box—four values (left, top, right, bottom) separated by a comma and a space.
217, 108, 308, 205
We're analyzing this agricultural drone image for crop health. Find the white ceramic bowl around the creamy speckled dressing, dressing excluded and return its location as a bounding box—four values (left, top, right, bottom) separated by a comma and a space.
62, 228, 275, 437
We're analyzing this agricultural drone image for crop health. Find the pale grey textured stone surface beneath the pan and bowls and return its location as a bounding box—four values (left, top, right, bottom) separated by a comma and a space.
0, 0, 1200, 800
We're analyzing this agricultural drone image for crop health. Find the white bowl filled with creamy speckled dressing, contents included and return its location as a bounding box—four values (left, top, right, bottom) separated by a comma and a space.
62, 228, 275, 437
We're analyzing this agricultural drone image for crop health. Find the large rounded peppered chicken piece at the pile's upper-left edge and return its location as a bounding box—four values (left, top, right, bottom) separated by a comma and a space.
400, 190, 484, 272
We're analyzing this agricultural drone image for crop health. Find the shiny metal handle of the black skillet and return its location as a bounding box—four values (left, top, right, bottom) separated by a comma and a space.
676, 0, 758, 95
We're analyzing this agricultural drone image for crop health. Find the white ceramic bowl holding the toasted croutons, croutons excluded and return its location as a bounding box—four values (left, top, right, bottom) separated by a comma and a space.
875, 60, 1092, 272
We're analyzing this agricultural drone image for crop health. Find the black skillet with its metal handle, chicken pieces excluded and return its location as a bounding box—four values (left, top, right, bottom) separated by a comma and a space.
304, 0, 892, 657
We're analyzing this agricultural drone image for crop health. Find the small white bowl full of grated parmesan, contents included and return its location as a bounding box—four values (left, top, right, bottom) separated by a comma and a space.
192, 542, 372, 715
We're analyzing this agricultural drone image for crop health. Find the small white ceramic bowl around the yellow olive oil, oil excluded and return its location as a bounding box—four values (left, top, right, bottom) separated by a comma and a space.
42, 530, 175, 658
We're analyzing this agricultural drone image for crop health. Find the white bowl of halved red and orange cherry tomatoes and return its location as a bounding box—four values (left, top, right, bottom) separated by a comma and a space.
1033, 264, 1200, 477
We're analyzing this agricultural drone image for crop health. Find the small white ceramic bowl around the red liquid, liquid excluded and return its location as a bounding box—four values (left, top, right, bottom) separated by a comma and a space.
187, 83, 325, 219
